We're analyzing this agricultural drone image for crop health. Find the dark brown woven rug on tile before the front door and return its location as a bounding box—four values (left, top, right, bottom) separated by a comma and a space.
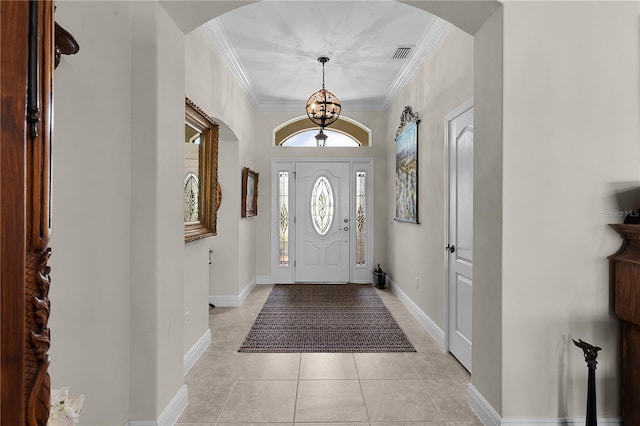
239, 284, 416, 352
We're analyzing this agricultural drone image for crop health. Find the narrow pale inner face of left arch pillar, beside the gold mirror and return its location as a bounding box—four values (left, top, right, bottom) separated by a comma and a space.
156, 4, 189, 416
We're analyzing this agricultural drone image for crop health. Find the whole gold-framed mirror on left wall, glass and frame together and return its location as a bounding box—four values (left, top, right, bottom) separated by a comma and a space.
184, 98, 219, 242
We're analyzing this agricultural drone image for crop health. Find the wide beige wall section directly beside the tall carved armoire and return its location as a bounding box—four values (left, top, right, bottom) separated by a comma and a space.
49, 2, 131, 426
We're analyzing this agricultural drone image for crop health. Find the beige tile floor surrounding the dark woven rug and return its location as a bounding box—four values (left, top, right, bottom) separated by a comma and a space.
177, 285, 482, 426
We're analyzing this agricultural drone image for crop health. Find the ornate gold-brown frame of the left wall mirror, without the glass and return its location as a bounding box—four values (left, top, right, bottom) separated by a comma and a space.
184, 98, 219, 243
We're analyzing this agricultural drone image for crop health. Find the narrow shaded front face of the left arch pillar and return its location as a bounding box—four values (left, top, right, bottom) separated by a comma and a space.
129, 3, 158, 419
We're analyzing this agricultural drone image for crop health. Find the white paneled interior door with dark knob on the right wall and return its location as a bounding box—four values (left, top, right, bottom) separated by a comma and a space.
446, 101, 473, 371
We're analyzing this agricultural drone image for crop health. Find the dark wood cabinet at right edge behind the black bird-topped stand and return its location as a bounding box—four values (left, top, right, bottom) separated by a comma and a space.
609, 225, 640, 425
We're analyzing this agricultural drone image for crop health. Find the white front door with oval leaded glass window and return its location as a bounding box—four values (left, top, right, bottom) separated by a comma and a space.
295, 162, 351, 283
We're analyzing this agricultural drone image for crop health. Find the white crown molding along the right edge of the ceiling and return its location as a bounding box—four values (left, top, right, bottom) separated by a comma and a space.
383, 17, 451, 110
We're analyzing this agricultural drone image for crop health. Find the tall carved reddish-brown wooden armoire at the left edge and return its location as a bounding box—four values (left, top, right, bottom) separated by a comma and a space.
0, 0, 78, 426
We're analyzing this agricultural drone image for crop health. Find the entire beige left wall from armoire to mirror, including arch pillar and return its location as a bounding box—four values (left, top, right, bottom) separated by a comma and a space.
50, 2, 184, 425
